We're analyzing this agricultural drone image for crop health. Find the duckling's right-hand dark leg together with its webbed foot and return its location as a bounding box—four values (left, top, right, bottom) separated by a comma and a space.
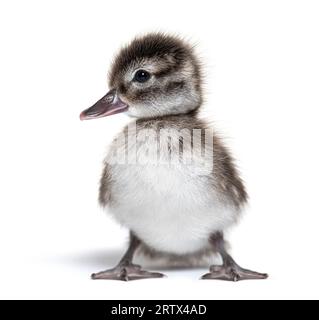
201, 232, 268, 281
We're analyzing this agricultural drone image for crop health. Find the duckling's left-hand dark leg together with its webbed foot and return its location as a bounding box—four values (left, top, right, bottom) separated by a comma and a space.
91, 233, 164, 281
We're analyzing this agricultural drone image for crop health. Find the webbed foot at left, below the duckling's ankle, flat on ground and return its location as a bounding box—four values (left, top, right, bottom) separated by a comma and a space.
91, 264, 164, 281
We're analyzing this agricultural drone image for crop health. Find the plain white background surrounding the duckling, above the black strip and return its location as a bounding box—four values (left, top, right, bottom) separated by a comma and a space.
0, 0, 319, 299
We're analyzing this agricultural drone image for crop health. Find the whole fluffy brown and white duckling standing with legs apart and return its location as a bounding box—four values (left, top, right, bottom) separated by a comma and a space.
80, 33, 267, 281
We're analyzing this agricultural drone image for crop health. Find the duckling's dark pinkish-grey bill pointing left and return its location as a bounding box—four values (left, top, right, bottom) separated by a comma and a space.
80, 89, 128, 120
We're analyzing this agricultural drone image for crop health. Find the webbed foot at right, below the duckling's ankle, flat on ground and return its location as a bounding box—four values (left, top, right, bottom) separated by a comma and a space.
201, 265, 268, 282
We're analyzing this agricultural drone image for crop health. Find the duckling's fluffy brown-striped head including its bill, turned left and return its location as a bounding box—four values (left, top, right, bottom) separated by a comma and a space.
81, 33, 202, 119
